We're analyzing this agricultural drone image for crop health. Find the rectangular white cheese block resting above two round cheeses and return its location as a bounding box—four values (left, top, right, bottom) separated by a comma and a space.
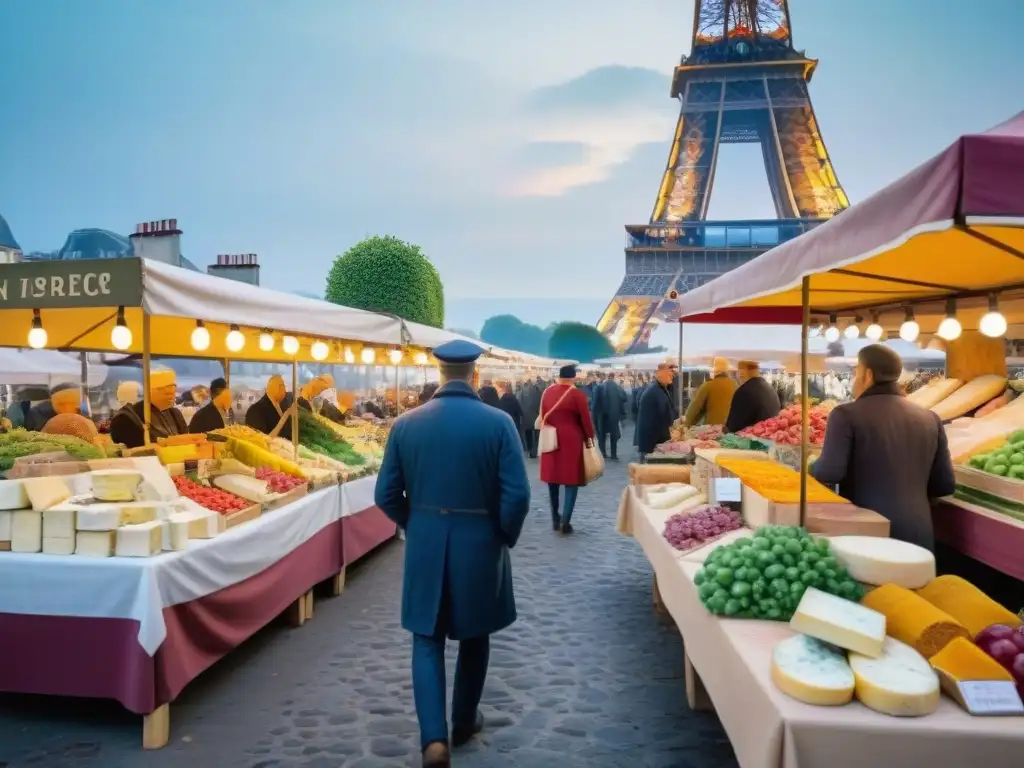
790, 587, 886, 656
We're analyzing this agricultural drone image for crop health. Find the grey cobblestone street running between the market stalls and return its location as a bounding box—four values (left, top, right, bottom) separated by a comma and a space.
0, 448, 735, 768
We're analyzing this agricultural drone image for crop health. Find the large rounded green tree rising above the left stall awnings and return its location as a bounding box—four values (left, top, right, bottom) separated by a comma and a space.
325, 234, 444, 328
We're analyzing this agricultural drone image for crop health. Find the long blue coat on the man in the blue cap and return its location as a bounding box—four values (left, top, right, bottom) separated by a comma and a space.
374, 382, 529, 640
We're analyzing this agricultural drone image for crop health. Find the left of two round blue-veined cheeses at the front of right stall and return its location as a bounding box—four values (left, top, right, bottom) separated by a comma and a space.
771, 635, 854, 707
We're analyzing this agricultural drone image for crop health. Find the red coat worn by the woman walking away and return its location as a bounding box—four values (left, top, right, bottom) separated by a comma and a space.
541, 384, 594, 485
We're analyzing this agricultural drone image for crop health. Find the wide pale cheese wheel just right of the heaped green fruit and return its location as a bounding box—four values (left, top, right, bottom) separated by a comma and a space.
828, 536, 935, 590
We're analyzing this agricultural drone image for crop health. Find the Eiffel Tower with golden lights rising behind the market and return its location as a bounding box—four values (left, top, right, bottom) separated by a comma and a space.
597, 0, 849, 353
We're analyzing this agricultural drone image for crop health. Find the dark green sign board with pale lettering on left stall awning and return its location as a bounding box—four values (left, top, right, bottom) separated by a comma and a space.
0, 258, 142, 309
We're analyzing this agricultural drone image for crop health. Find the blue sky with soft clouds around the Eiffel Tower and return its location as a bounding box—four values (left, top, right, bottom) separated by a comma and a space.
0, 0, 1024, 335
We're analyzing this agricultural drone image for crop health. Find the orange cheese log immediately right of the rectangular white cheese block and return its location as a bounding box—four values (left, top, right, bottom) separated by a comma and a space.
860, 584, 971, 658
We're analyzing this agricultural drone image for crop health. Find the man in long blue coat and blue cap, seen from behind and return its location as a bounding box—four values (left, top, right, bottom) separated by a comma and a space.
375, 341, 529, 768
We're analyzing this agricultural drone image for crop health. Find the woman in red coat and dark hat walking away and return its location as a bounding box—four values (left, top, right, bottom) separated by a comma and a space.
541, 366, 594, 534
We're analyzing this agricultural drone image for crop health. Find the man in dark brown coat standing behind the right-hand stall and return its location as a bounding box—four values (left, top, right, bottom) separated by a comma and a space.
811, 344, 956, 550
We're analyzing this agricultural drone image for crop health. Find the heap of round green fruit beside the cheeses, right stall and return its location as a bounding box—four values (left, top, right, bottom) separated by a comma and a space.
694, 525, 863, 622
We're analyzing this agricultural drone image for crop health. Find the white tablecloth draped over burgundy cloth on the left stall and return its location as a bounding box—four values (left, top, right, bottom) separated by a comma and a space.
0, 487, 346, 655
